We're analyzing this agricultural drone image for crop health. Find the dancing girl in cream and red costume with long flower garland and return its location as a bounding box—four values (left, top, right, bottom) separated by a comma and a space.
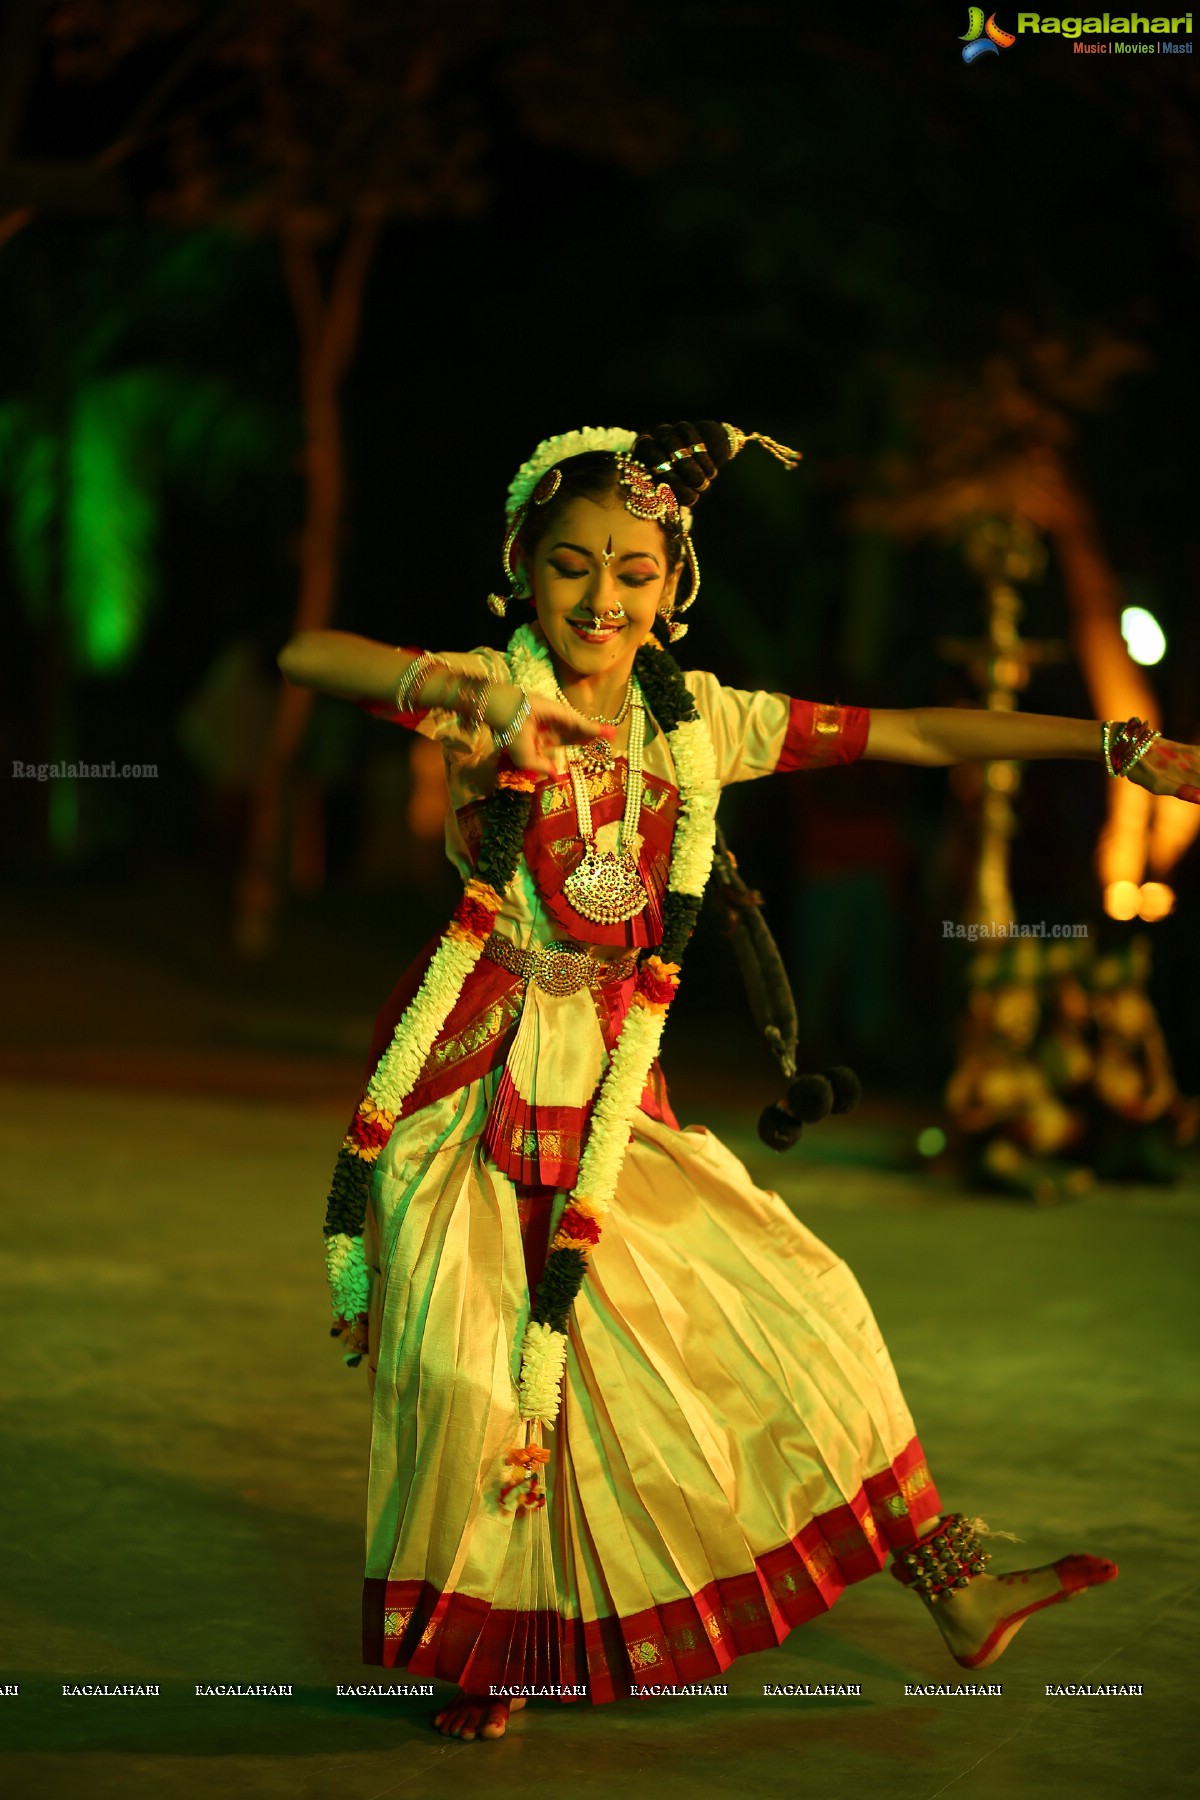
279, 421, 1200, 1739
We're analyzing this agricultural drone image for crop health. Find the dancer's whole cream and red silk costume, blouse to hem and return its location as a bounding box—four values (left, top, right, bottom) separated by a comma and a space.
341, 650, 941, 1701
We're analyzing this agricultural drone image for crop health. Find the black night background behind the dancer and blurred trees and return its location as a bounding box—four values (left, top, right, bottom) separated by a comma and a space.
0, 4, 1200, 1089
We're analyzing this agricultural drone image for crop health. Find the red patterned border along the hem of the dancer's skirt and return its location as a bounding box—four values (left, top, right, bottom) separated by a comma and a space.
362, 1438, 941, 1703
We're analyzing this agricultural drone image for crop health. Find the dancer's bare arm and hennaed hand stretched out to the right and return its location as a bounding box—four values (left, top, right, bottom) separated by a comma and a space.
864, 706, 1200, 805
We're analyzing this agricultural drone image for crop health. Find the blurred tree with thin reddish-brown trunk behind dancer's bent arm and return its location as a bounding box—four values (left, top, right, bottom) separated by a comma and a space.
7, 0, 680, 954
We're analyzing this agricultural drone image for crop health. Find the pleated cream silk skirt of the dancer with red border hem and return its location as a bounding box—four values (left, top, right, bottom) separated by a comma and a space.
363, 1071, 941, 1701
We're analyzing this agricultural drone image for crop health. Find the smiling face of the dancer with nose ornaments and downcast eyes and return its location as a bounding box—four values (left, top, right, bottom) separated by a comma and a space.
527, 497, 680, 677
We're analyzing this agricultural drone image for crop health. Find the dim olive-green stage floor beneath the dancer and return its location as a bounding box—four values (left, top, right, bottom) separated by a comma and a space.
0, 1082, 1200, 1800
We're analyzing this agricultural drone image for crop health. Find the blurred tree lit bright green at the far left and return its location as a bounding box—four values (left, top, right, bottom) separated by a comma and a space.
0, 227, 284, 860
